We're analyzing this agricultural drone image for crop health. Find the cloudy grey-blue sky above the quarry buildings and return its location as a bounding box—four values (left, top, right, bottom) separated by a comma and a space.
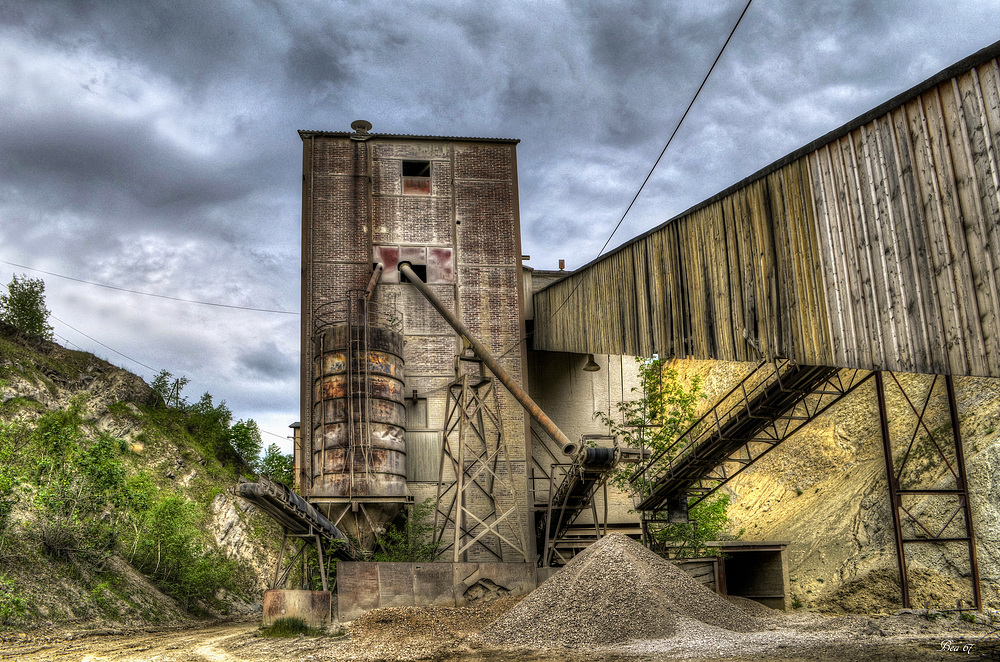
0, 0, 1000, 448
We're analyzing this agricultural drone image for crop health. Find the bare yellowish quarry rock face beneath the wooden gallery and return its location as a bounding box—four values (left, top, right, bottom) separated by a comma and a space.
678, 361, 1000, 612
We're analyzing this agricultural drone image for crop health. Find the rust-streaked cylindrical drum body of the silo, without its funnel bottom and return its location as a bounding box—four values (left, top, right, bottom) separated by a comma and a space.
311, 324, 406, 497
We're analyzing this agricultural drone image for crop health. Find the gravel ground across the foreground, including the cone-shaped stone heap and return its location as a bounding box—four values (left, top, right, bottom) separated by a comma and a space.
0, 535, 1000, 662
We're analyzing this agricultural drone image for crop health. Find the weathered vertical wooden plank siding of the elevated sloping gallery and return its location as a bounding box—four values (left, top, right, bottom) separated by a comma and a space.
533, 42, 1000, 377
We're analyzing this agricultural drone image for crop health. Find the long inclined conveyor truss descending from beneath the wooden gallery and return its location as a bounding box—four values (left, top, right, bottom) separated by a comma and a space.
630, 359, 873, 517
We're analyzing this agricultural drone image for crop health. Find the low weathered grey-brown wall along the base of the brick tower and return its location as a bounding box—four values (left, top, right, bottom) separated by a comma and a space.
337, 562, 538, 621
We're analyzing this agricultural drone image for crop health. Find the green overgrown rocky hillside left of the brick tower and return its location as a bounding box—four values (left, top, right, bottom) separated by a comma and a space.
0, 325, 278, 628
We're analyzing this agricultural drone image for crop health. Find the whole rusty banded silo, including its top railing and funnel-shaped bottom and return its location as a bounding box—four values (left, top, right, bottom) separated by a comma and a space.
309, 293, 409, 546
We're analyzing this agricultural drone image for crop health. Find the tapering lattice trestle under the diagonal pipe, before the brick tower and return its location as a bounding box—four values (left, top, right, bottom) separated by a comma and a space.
434, 357, 528, 563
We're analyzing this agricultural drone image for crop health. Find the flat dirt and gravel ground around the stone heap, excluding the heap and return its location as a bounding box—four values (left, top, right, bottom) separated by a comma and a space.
0, 604, 1000, 662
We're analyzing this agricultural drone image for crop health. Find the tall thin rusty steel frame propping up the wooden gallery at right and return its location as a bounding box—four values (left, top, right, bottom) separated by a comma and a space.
875, 372, 983, 611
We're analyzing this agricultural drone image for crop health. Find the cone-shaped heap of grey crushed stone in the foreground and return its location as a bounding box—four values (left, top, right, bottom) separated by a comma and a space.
479, 533, 758, 646
